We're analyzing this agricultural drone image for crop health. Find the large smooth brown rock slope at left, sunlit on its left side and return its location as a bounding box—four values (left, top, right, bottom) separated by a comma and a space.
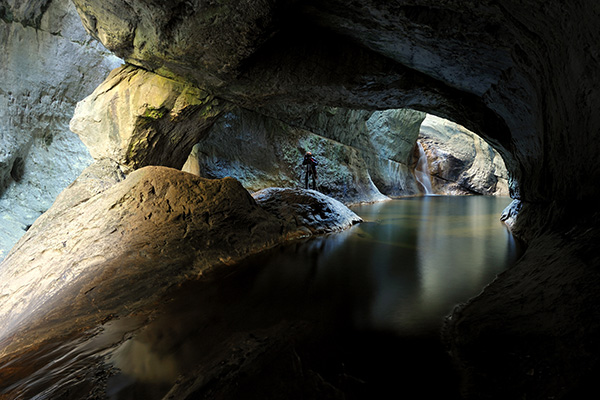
0, 166, 285, 355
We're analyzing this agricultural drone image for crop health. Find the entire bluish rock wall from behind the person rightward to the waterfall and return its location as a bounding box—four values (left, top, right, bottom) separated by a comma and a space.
184, 108, 424, 204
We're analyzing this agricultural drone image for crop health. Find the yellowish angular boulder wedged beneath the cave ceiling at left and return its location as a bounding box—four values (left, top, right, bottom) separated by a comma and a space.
70, 66, 227, 169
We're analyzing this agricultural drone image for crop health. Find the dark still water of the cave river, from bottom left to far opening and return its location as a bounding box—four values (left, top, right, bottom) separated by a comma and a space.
0, 196, 519, 400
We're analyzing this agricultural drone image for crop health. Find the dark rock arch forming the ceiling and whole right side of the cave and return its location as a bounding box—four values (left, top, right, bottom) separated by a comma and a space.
1, 0, 600, 399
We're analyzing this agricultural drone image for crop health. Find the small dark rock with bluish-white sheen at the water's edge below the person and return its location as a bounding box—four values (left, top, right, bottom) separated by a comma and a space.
252, 188, 362, 236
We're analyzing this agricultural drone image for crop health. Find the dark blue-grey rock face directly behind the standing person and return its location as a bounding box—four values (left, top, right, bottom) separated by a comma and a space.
184, 108, 387, 203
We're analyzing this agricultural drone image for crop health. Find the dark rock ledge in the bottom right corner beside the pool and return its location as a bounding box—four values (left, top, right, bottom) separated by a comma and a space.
444, 227, 600, 399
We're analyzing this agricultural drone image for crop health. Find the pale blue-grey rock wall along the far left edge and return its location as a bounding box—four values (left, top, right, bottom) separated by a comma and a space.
0, 0, 121, 260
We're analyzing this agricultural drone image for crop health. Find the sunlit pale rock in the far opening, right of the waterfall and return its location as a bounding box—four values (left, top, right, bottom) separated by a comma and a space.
419, 115, 508, 196
